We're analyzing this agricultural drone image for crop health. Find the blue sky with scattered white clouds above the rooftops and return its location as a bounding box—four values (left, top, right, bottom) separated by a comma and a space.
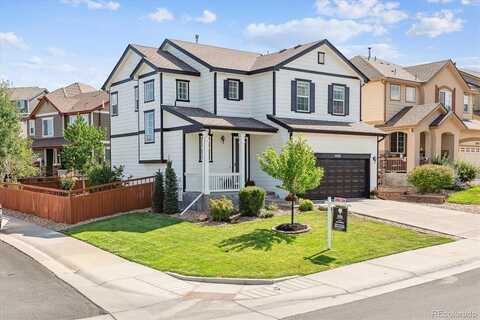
0, 0, 480, 90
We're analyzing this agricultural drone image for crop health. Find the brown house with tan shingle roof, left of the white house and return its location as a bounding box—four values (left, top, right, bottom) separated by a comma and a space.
27, 82, 110, 176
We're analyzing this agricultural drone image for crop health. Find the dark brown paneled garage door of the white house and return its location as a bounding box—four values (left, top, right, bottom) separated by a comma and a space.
305, 154, 370, 200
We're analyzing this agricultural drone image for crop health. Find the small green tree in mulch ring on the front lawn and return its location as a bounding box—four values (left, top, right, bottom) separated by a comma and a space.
258, 137, 323, 229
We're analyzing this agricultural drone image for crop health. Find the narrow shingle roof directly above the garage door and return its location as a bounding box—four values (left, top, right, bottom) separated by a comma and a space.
268, 116, 384, 135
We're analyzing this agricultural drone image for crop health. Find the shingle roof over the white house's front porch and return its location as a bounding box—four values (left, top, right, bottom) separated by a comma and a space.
162, 106, 278, 132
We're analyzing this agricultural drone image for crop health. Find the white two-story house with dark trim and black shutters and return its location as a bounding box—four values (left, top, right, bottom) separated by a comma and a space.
103, 39, 383, 199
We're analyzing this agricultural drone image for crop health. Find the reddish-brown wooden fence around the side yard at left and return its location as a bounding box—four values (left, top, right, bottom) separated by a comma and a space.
0, 177, 154, 224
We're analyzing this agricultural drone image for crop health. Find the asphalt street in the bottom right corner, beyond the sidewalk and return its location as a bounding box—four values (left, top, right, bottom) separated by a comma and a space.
287, 269, 480, 320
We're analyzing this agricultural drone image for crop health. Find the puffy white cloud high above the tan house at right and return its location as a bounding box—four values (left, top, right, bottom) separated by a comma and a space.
407, 10, 464, 38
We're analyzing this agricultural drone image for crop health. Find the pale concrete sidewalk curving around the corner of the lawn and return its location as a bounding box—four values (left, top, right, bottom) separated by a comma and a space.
0, 207, 480, 320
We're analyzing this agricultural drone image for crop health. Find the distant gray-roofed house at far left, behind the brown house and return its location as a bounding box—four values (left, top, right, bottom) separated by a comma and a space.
7, 87, 48, 136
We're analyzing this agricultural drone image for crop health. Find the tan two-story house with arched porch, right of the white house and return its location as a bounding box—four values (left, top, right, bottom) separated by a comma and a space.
351, 56, 480, 183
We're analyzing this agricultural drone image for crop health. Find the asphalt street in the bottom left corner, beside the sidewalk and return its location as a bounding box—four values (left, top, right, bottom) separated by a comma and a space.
0, 241, 104, 320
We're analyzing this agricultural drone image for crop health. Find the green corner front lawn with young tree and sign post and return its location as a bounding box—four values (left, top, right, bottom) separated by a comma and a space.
67, 211, 452, 278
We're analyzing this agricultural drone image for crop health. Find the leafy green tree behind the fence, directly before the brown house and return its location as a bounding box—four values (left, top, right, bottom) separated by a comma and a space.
61, 117, 105, 175
